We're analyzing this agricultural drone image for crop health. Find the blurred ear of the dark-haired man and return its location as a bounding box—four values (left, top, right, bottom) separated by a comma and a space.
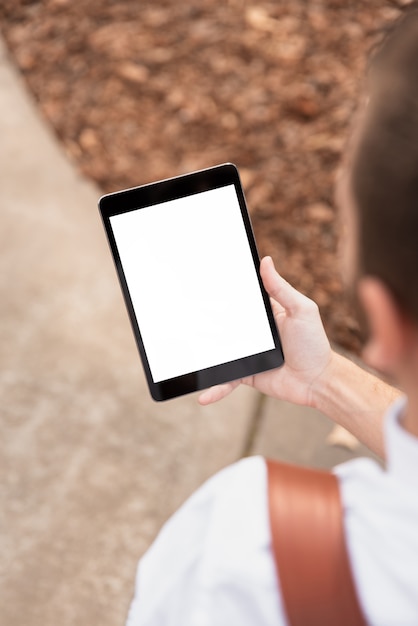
358, 276, 411, 376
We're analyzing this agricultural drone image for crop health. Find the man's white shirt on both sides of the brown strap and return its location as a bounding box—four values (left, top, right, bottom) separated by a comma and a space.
127, 399, 418, 626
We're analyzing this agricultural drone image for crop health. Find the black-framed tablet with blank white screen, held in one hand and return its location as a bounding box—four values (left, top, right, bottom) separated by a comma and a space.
99, 163, 283, 400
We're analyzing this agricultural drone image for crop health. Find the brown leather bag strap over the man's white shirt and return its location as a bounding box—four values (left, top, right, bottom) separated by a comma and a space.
267, 461, 366, 626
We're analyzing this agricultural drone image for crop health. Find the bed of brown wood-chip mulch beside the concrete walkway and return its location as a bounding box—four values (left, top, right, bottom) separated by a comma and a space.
0, 0, 408, 351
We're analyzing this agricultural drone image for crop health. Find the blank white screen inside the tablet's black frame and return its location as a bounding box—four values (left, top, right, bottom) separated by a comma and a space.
110, 185, 275, 382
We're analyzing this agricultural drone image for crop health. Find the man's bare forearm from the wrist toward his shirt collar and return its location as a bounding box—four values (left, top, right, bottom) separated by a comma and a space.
312, 353, 401, 457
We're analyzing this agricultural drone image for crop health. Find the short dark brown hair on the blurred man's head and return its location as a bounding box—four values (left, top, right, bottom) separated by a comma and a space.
351, 2, 418, 321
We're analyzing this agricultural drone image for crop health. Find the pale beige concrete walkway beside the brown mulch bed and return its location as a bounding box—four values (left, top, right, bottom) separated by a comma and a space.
0, 35, 376, 626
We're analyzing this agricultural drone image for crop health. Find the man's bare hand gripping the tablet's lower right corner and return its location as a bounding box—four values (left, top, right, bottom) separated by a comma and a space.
199, 257, 333, 406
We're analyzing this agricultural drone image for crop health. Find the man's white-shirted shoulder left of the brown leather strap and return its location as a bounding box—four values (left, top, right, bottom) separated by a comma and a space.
128, 457, 282, 626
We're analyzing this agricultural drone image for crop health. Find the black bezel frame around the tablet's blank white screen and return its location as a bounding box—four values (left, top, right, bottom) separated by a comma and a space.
99, 163, 284, 401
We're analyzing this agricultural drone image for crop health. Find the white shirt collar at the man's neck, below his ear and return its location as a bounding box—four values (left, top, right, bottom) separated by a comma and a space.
385, 397, 418, 487
